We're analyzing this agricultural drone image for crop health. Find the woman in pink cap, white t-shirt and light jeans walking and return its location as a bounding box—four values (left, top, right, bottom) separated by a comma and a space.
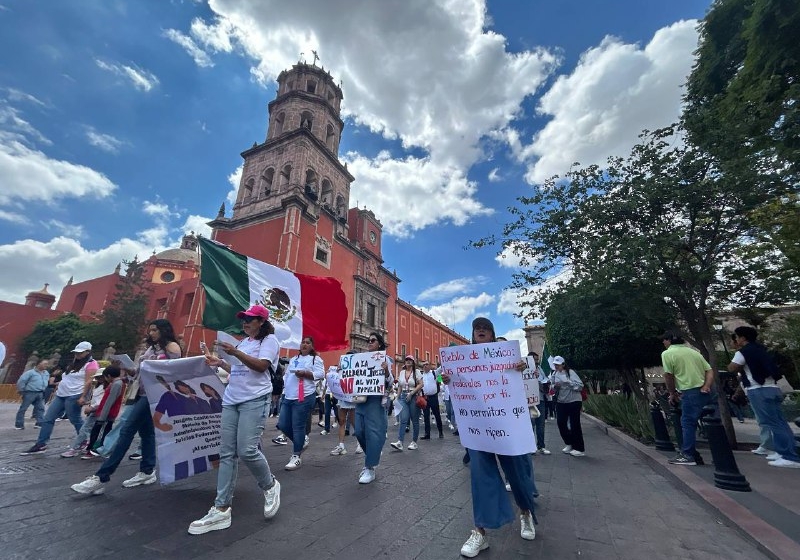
189, 305, 281, 535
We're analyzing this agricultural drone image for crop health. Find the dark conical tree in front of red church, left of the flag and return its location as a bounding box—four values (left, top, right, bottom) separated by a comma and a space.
96, 258, 151, 354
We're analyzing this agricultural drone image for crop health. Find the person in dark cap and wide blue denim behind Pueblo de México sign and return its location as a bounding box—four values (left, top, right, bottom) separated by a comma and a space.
442, 317, 536, 558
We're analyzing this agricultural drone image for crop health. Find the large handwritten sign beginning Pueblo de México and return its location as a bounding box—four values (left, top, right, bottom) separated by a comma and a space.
439, 340, 536, 455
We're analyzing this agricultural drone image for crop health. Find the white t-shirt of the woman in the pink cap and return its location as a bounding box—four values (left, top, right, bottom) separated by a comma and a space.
222, 334, 281, 405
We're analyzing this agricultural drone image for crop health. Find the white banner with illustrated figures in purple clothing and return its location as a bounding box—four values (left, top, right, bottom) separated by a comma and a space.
139, 356, 225, 484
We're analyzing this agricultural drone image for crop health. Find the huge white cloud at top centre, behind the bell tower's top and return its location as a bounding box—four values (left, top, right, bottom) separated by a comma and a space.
178, 0, 558, 236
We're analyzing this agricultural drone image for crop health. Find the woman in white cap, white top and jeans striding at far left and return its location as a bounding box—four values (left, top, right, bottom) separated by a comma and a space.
21, 340, 100, 455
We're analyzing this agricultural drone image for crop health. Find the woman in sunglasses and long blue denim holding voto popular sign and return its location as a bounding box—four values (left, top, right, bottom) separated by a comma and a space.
355, 332, 392, 484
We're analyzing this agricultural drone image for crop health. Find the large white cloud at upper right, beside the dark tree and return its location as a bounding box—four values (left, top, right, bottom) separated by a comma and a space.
507, 20, 697, 184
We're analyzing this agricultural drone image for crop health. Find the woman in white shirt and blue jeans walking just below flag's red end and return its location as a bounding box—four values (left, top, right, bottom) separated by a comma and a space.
278, 336, 325, 471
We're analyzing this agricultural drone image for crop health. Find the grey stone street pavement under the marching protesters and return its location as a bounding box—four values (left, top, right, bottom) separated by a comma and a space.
0, 403, 769, 560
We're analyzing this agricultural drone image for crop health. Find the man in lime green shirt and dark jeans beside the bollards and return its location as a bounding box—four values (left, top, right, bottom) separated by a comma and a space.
661, 331, 714, 466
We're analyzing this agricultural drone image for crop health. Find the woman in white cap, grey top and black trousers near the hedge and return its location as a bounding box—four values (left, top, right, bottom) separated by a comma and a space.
552, 356, 586, 457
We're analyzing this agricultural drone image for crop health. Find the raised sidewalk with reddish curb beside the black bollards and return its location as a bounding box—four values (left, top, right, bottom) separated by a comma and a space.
584, 415, 800, 560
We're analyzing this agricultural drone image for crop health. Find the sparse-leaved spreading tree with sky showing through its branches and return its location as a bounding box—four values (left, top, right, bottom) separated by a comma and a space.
473, 126, 800, 442
